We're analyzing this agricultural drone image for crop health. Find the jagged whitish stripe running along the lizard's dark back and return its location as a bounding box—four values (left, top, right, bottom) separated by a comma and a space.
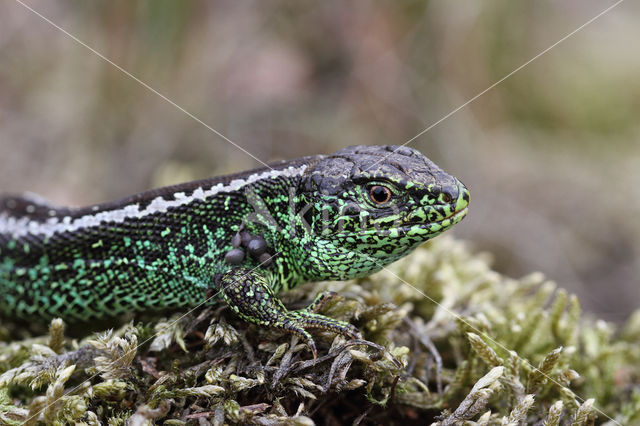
0, 165, 307, 238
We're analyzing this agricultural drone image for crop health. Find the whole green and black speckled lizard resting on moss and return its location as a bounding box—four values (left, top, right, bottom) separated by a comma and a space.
0, 146, 469, 355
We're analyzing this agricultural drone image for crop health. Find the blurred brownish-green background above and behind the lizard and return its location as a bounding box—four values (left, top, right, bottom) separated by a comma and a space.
0, 0, 640, 321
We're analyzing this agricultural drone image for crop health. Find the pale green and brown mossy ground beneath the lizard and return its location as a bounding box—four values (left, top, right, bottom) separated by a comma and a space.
0, 237, 640, 425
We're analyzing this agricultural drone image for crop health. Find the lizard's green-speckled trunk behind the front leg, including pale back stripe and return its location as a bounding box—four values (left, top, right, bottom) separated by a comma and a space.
0, 158, 310, 320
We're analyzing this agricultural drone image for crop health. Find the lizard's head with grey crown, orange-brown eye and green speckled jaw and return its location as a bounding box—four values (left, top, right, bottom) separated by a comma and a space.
297, 146, 469, 280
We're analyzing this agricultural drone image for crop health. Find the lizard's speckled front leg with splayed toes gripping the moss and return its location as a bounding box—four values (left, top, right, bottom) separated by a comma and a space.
217, 268, 360, 359
